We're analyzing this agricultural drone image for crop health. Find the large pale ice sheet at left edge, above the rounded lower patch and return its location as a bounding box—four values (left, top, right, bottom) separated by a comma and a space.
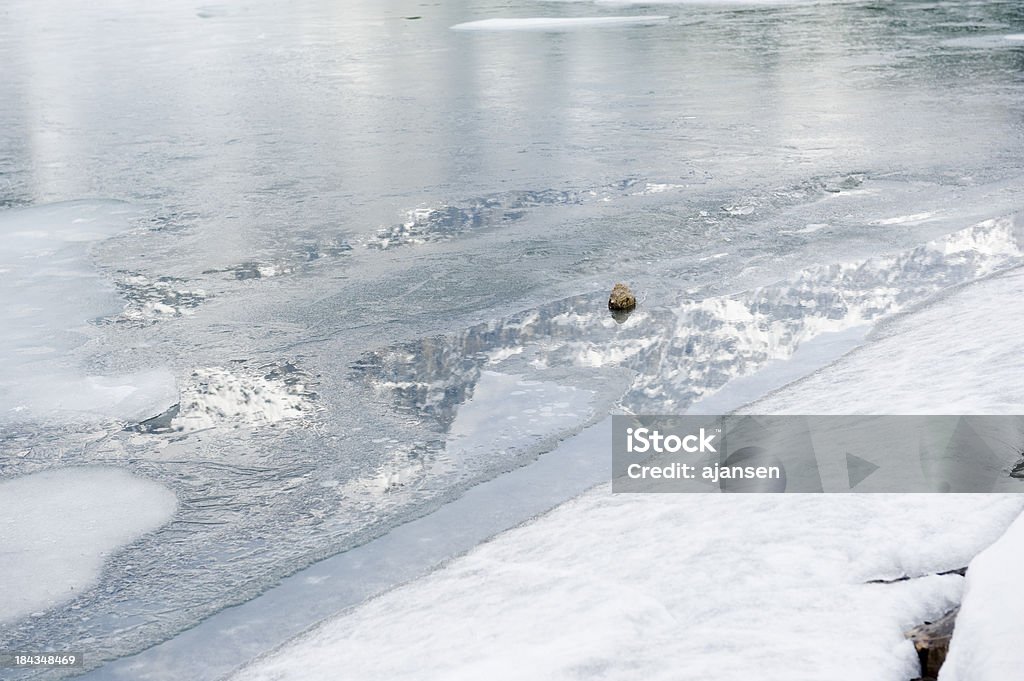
0, 201, 177, 422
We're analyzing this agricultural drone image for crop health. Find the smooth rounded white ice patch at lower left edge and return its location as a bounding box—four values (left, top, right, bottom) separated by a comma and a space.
0, 466, 177, 623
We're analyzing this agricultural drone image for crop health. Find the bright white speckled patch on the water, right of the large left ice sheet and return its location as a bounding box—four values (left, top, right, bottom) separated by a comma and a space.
171, 367, 313, 432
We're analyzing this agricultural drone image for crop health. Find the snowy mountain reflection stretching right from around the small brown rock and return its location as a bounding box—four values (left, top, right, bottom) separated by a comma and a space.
358, 218, 1024, 419
